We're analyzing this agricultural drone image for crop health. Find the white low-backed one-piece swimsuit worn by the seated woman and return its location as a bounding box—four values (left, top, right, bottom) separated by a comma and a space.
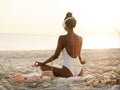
62, 48, 81, 76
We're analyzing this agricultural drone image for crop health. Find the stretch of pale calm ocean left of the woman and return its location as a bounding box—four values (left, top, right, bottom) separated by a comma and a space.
0, 34, 58, 50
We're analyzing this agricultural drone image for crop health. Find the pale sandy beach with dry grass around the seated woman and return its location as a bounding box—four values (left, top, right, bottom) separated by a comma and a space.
0, 49, 120, 90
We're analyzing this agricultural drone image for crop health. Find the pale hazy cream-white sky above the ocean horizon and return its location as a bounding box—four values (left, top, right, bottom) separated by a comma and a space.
0, 0, 120, 49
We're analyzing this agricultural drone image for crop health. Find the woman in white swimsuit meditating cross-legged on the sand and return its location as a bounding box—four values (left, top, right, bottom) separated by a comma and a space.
34, 12, 85, 77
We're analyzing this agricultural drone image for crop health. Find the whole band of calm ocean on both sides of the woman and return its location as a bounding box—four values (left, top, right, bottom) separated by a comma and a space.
0, 34, 120, 50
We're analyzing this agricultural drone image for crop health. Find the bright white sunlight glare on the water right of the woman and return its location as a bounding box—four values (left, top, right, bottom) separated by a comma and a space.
83, 36, 118, 49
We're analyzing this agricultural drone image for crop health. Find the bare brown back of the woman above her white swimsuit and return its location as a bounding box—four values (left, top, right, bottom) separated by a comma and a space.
64, 33, 82, 58
